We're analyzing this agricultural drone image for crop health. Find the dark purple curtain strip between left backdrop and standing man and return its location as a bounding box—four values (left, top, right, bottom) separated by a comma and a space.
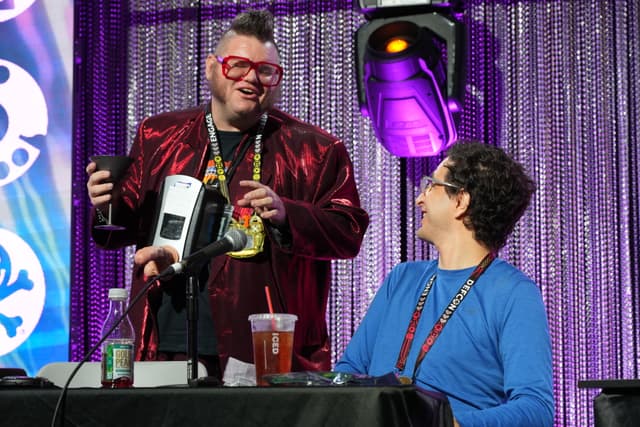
70, 1, 128, 360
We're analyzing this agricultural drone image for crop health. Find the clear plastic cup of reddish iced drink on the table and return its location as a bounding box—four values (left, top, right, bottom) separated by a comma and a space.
249, 313, 298, 386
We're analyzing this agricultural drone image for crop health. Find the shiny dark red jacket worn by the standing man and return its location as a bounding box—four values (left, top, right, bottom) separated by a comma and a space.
93, 108, 369, 370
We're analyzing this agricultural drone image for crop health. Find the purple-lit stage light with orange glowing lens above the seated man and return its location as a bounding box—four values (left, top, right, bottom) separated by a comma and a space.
356, 12, 464, 157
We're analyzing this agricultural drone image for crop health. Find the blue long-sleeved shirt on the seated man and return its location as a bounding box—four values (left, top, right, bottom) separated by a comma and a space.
335, 259, 554, 427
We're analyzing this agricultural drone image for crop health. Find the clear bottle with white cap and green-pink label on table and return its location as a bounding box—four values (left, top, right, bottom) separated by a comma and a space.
101, 288, 135, 388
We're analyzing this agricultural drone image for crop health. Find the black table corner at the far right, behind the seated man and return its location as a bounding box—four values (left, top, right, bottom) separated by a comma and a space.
578, 379, 640, 427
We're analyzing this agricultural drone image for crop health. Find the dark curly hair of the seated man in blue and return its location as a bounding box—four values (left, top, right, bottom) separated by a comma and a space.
445, 141, 536, 250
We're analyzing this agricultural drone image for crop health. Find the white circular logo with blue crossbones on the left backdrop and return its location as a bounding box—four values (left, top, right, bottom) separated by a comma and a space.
0, 228, 45, 356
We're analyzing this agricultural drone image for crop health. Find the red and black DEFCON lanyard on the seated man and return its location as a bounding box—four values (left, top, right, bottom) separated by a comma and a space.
396, 252, 496, 382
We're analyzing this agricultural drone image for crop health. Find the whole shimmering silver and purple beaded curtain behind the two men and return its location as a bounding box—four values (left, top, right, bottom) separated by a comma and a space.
71, 0, 640, 426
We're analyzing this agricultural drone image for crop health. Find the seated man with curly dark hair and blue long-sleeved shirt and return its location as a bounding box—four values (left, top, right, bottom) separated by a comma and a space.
335, 142, 554, 427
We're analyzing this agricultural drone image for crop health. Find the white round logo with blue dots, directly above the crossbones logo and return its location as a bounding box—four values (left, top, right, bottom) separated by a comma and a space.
0, 59, 48, 187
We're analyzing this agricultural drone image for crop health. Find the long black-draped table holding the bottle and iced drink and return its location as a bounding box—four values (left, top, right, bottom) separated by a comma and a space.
0, 386, 452, 427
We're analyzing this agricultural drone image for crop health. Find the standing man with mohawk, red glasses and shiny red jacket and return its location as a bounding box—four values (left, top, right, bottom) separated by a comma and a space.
87, 11, 369, 376
